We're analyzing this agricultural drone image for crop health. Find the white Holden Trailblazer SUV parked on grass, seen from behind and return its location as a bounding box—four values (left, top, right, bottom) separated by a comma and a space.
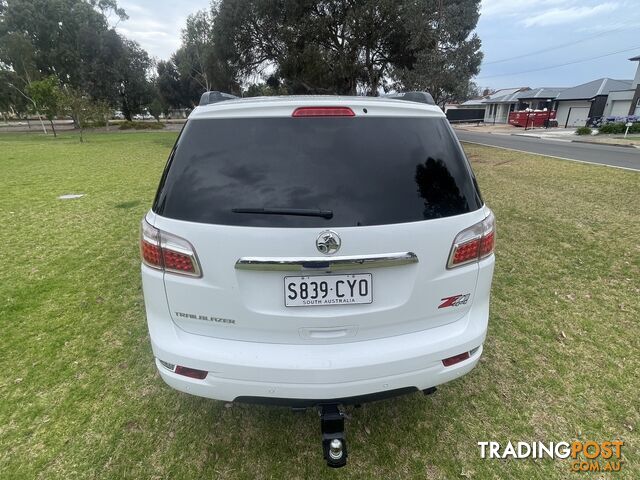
141, 92, 495, 464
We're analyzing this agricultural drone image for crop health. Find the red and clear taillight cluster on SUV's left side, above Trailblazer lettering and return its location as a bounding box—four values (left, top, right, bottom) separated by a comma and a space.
140, 219, 201, 277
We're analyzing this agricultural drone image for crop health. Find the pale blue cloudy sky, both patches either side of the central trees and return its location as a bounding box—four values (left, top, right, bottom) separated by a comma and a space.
118, 0, 640, 88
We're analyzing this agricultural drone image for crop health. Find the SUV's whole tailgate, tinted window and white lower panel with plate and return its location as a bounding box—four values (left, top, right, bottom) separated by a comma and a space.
154, 109, 484, 343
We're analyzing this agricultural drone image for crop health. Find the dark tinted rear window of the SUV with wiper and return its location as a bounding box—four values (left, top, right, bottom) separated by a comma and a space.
154, 117, 482, 227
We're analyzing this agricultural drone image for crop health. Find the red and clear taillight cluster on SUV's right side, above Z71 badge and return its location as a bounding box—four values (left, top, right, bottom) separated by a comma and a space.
447, 211, 496, 268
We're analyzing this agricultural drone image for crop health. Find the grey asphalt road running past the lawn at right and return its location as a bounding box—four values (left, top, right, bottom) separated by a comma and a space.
456, 129, 640, 171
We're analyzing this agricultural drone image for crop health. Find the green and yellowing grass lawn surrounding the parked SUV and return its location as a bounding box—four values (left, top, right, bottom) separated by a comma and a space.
0, 132, 640, 480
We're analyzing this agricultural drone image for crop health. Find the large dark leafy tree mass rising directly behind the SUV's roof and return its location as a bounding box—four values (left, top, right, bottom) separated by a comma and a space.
213, 0, 482, 99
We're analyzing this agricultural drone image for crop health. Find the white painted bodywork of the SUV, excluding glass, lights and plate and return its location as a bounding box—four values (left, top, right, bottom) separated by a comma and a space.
142, 97, 494, 401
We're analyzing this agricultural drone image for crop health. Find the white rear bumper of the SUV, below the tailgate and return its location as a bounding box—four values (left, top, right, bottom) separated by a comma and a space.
143, 259, 493, 404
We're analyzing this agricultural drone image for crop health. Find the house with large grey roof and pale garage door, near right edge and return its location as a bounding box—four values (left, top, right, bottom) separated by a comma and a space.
554, 78, 632, 128
